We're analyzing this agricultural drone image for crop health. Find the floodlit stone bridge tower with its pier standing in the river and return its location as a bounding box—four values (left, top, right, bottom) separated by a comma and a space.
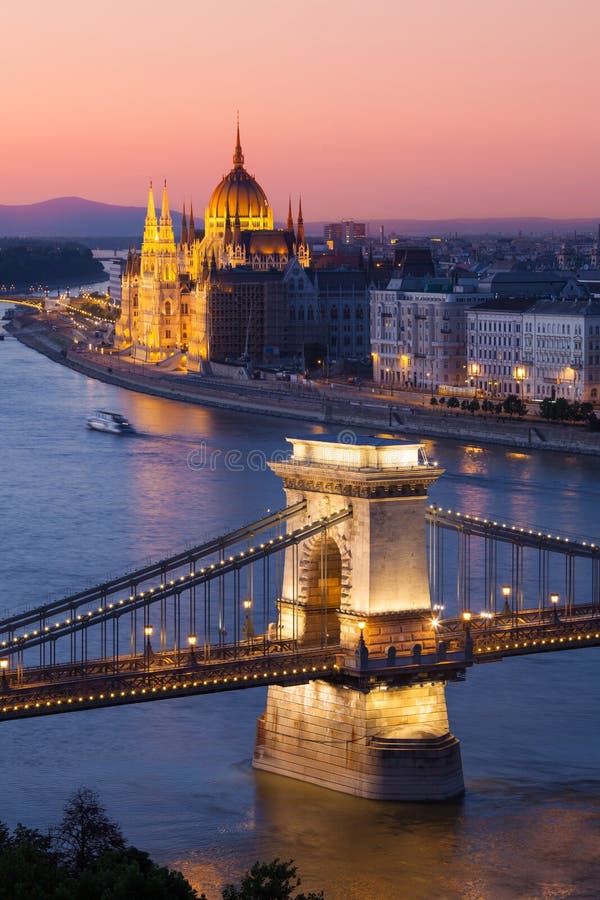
254, 434, 464, 801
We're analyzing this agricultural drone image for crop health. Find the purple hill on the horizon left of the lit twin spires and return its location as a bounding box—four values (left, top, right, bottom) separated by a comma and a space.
0, 197, 181, 239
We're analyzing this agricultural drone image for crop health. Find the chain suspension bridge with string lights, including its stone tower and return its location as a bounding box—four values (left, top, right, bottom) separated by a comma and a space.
0, 436, 600, 800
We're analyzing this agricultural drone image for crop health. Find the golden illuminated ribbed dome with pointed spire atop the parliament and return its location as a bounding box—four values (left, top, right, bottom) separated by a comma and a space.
205, 126, 273, 237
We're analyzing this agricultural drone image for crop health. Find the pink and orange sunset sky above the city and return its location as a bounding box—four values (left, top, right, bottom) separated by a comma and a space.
0, 0, 600, 221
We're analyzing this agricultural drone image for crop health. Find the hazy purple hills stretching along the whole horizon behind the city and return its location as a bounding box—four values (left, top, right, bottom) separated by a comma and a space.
0, 197, 600, 243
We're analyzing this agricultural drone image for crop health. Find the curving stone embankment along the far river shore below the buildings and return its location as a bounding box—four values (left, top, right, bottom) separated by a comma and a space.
9, 315, 600, 456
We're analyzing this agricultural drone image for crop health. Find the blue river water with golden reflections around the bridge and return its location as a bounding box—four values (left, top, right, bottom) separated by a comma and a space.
0, 337, 600, 900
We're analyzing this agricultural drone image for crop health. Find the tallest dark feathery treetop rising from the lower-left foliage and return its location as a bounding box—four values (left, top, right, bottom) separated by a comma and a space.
54, 788, 125, 872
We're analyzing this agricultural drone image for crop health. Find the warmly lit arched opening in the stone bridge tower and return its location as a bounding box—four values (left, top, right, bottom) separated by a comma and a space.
300, 534, 342, 647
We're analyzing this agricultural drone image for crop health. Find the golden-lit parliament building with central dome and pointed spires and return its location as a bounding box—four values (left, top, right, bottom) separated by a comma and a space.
115, 126, 314, 371
